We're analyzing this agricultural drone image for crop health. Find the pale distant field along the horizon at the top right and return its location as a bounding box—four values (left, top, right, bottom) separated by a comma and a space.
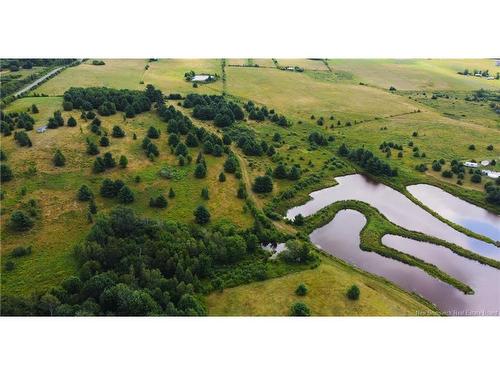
328, 59, 500, 90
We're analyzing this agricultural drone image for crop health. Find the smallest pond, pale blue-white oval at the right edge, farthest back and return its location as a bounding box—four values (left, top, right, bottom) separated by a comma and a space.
407, 184, 500, 241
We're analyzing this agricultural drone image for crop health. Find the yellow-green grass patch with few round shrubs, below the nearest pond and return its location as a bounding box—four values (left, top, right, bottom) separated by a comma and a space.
206, 256, 436, 316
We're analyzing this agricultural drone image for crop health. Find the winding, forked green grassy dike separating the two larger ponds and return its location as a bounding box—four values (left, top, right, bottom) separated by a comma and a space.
301, 200, 500, 294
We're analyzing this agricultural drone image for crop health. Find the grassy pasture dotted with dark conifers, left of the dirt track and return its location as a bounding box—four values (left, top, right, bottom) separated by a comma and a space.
1, 98, 252, 295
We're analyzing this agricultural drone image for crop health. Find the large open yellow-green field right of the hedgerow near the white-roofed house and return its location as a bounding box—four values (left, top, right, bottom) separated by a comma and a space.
226, 67, 418, 122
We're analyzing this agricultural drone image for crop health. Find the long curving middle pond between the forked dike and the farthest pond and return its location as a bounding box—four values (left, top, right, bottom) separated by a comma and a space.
286, 174, 500, 260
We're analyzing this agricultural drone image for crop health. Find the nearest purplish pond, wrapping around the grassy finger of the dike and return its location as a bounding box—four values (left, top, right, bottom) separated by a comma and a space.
310, 210, 500, 315
